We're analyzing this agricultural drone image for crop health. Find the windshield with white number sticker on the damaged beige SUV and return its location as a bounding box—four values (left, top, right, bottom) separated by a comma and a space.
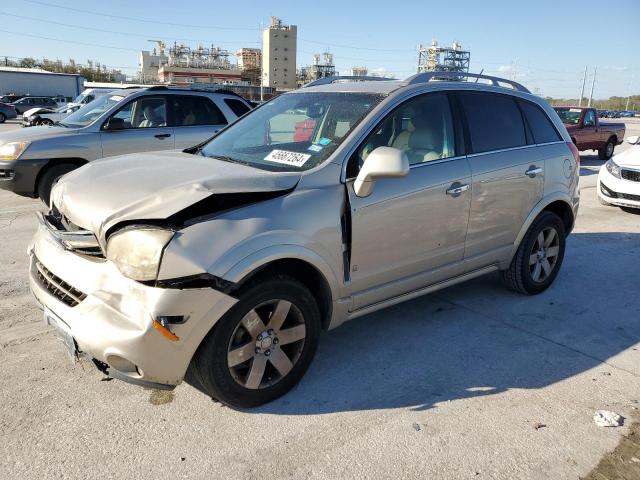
200, 92, 384, 171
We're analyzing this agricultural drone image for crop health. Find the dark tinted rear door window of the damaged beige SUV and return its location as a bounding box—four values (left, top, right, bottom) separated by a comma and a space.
460, 93, 527, 153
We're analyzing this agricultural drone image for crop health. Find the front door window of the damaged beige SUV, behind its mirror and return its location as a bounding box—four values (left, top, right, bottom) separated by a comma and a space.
347, 93, 455, 177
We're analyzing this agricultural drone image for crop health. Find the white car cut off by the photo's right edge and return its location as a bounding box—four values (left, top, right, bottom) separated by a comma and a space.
598, 136, 640, 208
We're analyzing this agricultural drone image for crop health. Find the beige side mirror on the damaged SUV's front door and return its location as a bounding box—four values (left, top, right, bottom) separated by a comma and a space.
353, 147, 409, 197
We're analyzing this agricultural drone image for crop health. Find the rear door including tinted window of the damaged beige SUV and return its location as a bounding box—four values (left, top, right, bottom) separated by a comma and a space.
459, 92, 544, 269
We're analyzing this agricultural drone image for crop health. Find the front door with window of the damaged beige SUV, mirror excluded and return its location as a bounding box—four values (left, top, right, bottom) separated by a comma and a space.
347, 93, 471, 310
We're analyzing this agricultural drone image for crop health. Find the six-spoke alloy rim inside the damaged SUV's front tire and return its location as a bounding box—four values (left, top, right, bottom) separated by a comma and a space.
227, 299, 306, 390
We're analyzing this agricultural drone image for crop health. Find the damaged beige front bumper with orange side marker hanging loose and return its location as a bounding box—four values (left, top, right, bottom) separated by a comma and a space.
28, 216, 236, 388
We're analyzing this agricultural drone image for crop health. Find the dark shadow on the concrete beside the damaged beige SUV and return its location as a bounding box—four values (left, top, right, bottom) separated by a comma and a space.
184, 233, 640, 415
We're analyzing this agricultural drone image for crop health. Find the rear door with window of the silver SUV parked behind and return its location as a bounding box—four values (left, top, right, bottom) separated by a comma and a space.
169, 95, 228, 149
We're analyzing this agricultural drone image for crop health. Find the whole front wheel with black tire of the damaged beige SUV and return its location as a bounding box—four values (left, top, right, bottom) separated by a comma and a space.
193, 276, 320, 409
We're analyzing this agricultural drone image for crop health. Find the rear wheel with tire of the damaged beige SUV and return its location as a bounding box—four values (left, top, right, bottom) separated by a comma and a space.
502, 212, 566, 295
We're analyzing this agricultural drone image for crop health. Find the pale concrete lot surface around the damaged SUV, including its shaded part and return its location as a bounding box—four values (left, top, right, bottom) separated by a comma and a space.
0, 119, 640, 480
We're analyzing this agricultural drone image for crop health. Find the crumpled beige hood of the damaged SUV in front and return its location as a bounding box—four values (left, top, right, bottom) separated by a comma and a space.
51, 151, 301, 241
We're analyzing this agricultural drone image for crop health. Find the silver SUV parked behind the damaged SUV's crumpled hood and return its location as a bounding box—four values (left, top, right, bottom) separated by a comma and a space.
0, 87, 250, 203
